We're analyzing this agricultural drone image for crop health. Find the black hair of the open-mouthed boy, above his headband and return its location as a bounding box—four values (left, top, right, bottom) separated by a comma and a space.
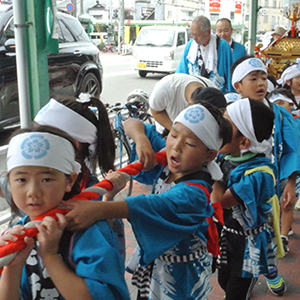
197, 101, 232, 147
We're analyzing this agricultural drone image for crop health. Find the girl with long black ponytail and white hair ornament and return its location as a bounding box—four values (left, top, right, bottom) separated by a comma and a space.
34, 94, 126, 260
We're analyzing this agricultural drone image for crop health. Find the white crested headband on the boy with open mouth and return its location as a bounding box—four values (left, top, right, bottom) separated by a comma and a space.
173, 104, 223, 180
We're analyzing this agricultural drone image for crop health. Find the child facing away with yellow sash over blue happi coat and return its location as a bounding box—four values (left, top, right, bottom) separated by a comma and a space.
212, 99, 285, 300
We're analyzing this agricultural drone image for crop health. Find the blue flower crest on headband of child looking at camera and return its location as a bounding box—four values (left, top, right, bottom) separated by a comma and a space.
21, 134, 50, 159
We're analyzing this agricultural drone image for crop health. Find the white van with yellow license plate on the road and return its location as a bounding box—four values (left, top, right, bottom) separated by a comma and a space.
132, 26, 190, 77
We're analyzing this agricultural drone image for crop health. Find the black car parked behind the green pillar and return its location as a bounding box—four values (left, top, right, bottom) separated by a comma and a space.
0, 6, 103, 132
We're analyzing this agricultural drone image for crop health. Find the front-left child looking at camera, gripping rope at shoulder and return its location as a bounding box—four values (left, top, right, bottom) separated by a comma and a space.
0, 126, 129, 300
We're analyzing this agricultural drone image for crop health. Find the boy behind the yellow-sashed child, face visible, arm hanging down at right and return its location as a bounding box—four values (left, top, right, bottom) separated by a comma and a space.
231, 56, 300, 255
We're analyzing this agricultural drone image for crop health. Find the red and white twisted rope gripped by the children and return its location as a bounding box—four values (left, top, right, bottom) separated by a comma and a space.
0, 152, 167, 274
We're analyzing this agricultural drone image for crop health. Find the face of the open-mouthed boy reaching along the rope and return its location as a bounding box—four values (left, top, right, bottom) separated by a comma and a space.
166, 123, 217, 180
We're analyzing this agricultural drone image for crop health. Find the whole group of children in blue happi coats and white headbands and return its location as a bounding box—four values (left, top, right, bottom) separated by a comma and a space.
0, 56, 300, 300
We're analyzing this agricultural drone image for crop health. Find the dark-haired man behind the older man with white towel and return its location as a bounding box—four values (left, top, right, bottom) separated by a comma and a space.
216, 18, 247, 62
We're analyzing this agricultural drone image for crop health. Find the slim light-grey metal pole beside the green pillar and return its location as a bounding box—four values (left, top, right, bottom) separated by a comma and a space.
13, 0, 32, 128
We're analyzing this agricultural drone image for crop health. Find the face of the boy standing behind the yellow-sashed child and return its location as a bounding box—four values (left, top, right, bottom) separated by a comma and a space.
234, 71, 268, 101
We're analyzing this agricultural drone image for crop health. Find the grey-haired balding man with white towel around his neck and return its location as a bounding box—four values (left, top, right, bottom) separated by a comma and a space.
176, 16, 234, 93
